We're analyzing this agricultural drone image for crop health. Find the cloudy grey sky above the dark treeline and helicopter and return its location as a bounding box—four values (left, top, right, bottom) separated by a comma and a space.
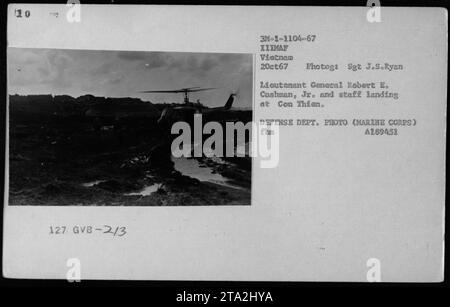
8, 48, 253, 107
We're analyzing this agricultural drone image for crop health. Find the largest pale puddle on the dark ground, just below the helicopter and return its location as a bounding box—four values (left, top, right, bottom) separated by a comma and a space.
172, 157, 243, 190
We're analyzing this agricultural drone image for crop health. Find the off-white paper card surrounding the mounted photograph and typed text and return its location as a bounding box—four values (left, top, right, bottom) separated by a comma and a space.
3, 5, 447, 281
